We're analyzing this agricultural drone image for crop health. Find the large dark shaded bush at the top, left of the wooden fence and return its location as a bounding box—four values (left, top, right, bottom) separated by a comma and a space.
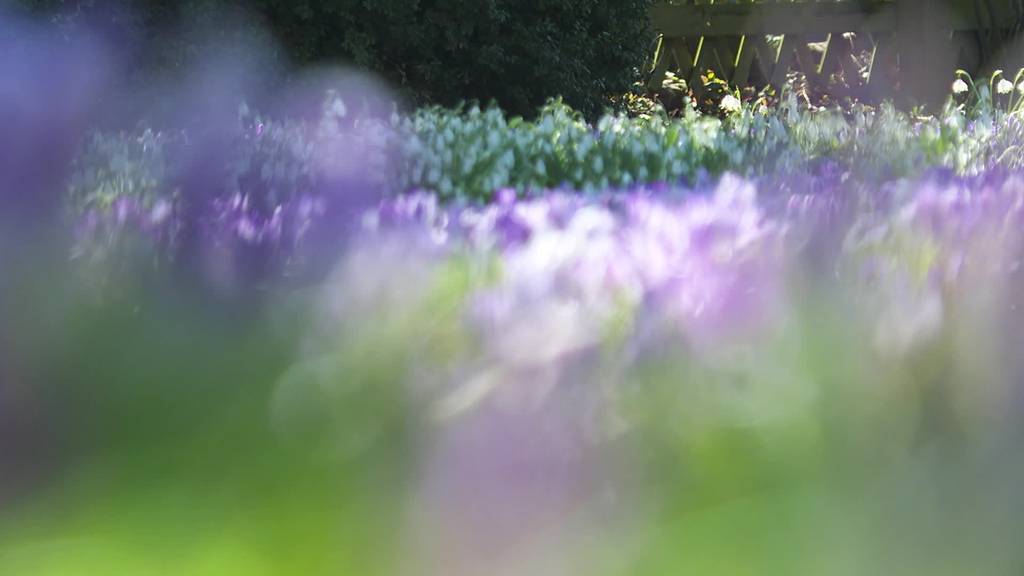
14, 0, 651, 114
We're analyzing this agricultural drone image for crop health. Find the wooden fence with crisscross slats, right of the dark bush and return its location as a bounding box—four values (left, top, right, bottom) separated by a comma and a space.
648, 0, 1024, 97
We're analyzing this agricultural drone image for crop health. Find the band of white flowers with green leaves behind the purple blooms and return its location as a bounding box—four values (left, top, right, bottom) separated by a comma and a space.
64, 94, 1024, 208
